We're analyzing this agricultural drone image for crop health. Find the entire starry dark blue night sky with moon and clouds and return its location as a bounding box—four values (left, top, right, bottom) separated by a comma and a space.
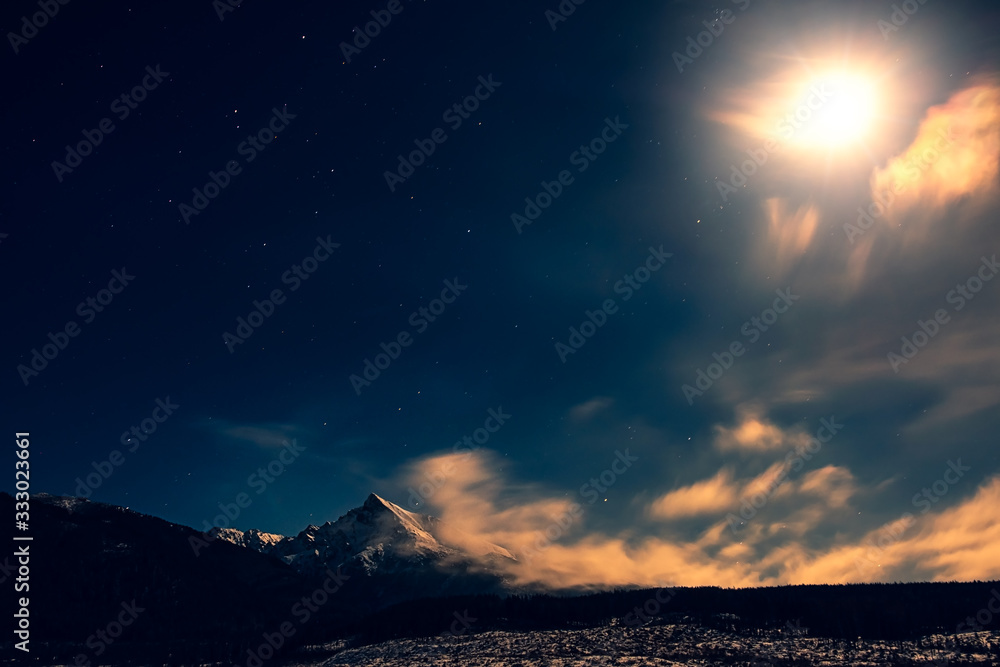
0, 0, 1000, 585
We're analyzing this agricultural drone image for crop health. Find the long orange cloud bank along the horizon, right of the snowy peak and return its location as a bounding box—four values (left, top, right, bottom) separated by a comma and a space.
396, 449, 1000, 589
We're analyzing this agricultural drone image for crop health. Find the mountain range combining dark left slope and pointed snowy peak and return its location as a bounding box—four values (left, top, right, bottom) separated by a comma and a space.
0, 493, 516, 664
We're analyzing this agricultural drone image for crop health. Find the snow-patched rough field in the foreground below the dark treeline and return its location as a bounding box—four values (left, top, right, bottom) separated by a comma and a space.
290, 625, 1000, 667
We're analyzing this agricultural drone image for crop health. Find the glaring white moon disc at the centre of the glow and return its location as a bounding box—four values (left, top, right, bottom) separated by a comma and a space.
792, 73, 875, 150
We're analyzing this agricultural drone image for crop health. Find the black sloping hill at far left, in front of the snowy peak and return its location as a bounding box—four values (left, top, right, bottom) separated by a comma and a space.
0, 494, 306, 664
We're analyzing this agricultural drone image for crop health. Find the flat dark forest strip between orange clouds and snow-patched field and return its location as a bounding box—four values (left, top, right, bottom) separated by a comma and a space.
348, 581, 1000, 644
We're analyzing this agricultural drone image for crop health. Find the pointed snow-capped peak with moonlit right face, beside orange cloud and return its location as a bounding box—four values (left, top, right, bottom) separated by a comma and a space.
218, 493, 516, 599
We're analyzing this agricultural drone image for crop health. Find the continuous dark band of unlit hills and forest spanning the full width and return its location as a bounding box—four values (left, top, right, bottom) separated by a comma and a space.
0, 494, 1000, 664
